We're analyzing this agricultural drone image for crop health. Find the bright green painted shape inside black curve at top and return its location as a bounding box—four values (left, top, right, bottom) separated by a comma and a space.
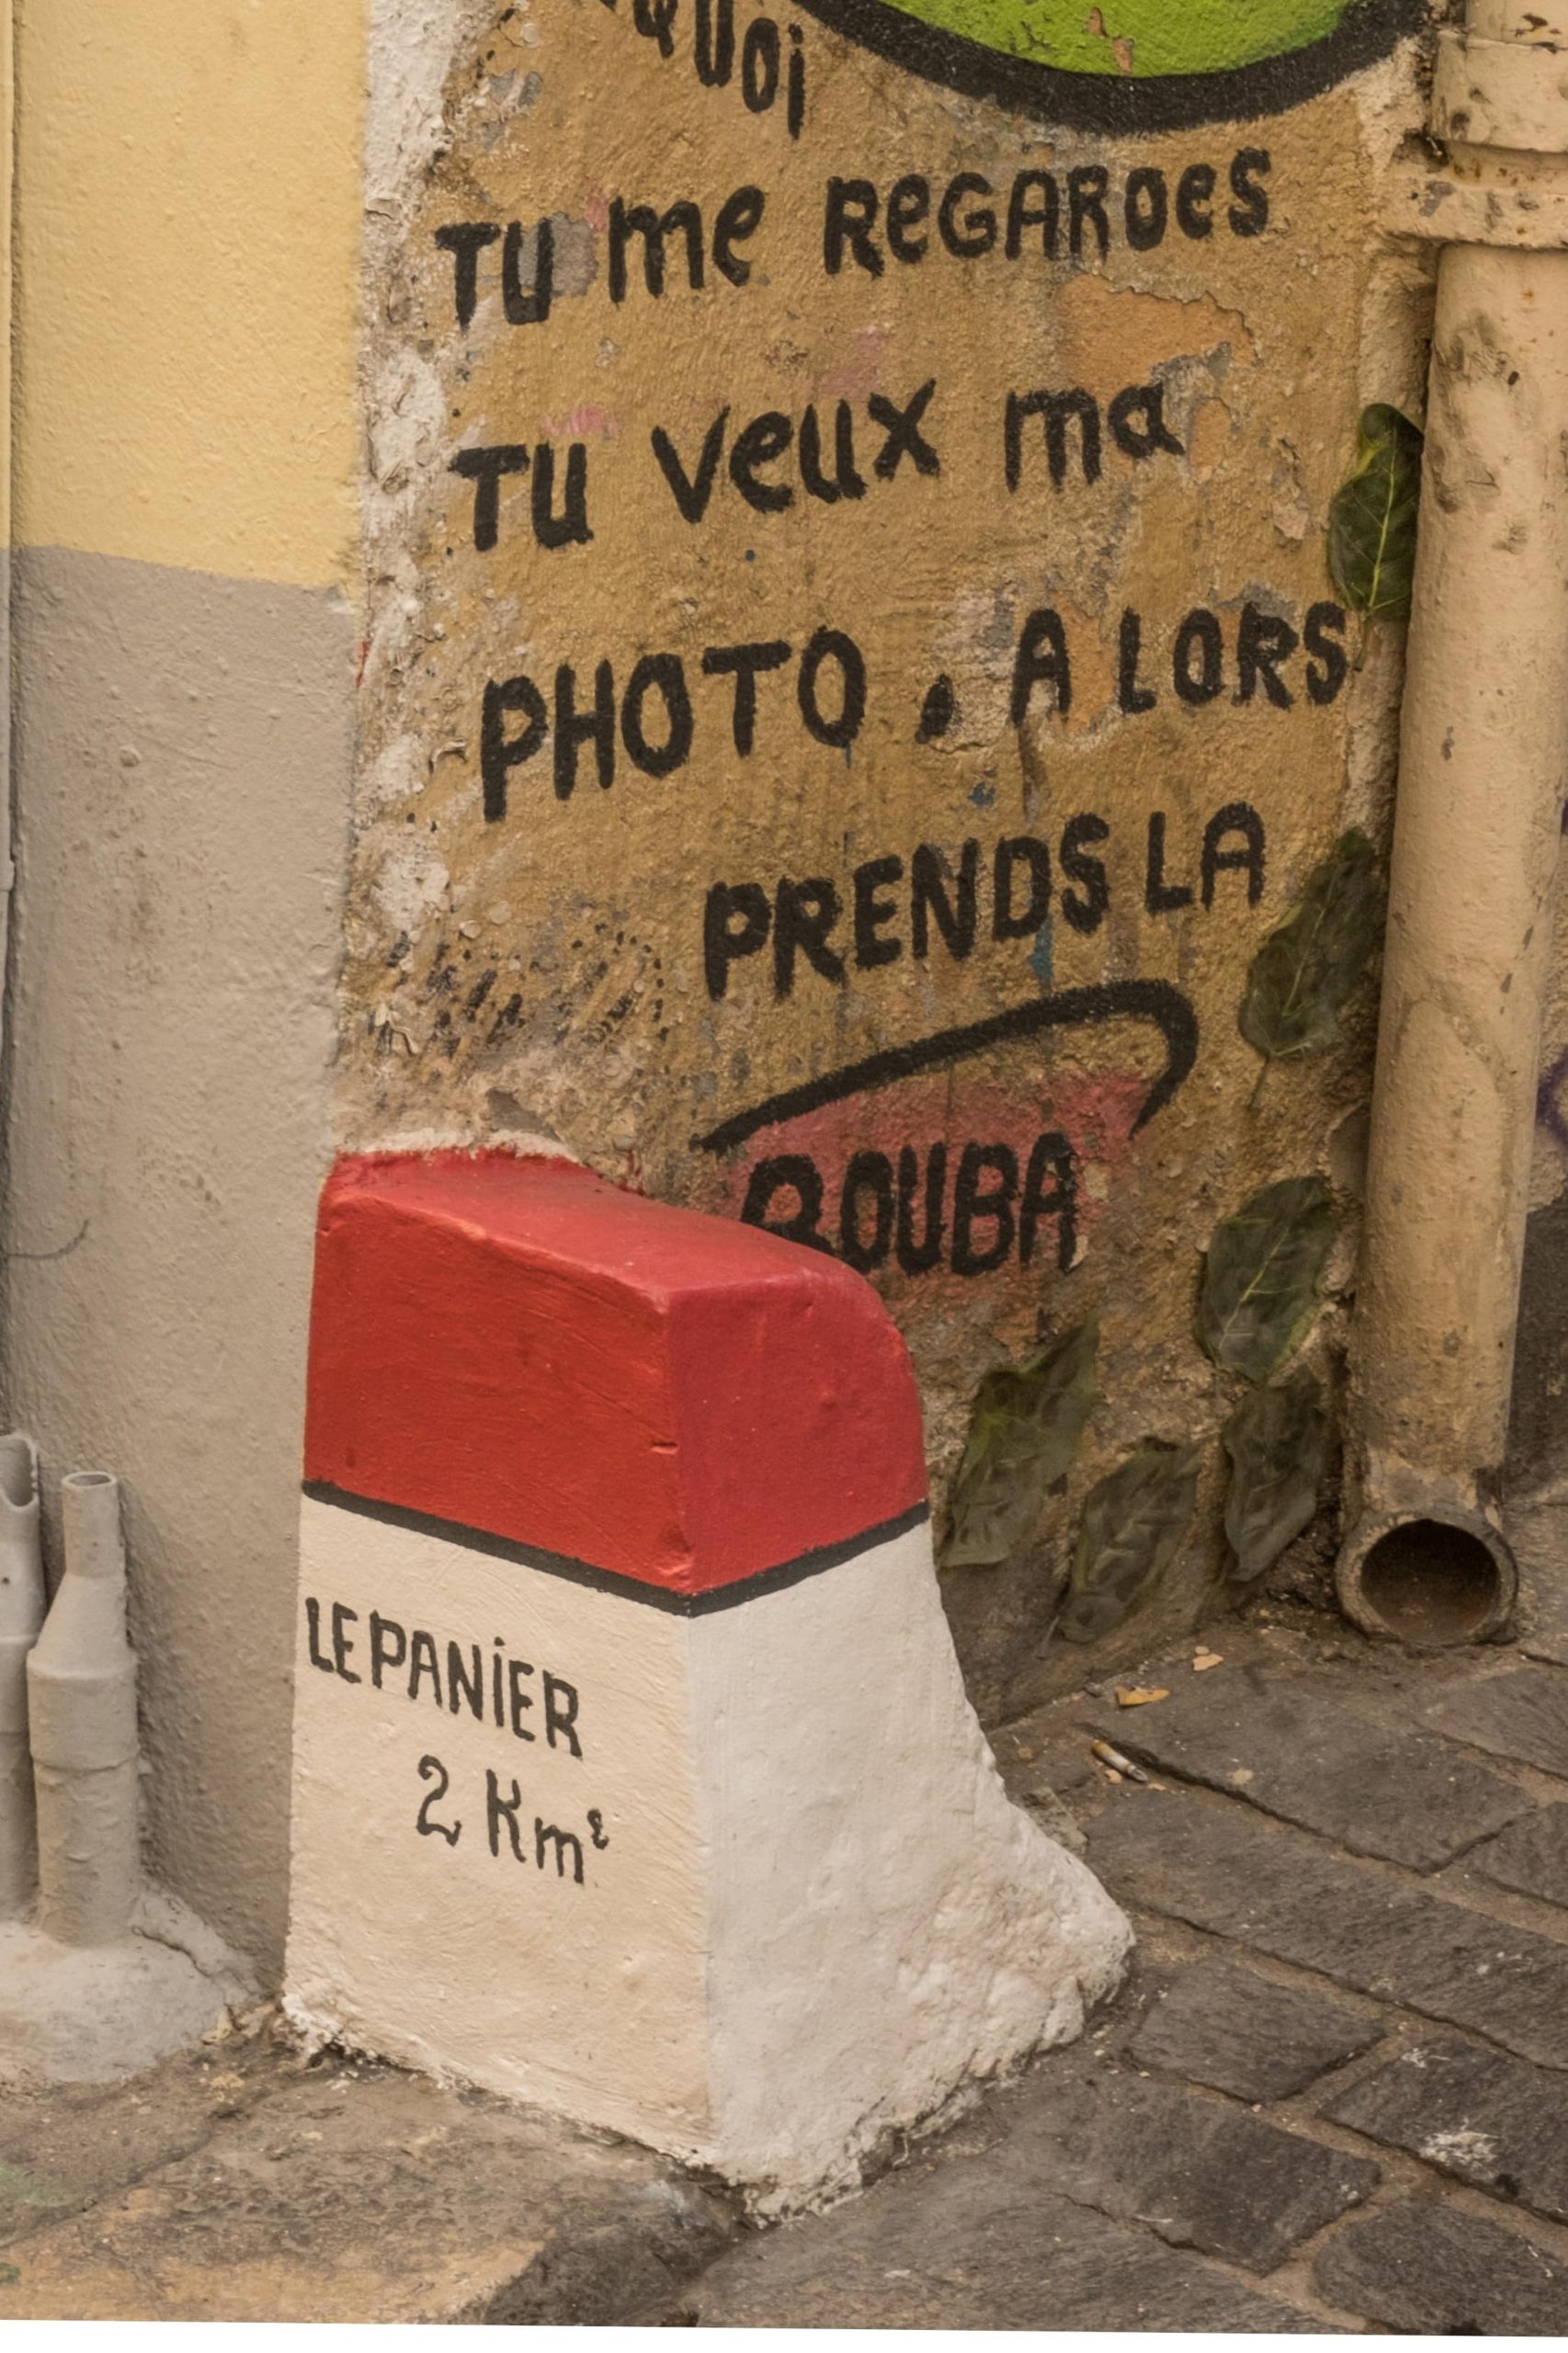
892, 0, 1358, 80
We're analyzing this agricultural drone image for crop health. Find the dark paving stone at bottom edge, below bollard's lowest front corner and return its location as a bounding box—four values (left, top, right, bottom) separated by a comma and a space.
673, 2127, 1324, 2335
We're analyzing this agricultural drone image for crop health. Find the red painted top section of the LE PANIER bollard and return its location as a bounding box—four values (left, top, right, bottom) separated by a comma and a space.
306, 1151, 926, 1596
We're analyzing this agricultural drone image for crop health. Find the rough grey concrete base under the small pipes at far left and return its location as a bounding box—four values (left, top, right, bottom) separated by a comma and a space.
0, 1890, 256, 2085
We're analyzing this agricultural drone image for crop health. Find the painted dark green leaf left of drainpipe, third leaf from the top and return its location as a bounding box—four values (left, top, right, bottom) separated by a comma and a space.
1199, 1176, 1335, 1381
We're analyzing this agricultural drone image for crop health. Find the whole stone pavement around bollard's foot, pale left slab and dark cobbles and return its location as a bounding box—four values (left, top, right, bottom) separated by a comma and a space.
0, 1619, 1568, 2335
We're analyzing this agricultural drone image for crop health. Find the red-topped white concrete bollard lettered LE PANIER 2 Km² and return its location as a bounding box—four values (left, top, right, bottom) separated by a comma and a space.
288, 1153, 1131, 2207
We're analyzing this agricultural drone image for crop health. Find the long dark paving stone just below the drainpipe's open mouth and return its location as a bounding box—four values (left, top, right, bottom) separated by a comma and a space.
1095, 1671, 1530, 1870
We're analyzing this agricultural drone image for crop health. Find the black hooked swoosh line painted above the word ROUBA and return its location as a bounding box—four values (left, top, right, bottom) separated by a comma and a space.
692, 982, 1199, 1153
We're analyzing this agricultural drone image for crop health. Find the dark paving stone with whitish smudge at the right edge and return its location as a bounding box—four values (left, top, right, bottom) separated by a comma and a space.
1324, 2042, 1568, 2222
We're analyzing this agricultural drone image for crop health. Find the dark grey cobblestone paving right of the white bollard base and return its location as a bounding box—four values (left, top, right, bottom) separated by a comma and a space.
664, 1619, 1568, 2335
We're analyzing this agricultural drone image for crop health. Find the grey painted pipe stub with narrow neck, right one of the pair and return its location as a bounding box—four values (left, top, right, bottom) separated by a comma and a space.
28, 1471, 139, 1944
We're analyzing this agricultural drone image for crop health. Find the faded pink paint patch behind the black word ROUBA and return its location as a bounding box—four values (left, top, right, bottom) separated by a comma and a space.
701, 1071, 1149, 1287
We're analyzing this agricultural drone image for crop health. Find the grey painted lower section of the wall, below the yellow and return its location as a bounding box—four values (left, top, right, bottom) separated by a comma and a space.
0, 548, 356, 1976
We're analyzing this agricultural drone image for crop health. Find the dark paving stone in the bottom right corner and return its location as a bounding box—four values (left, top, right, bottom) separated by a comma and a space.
1313, 2198, 1568, 2336
